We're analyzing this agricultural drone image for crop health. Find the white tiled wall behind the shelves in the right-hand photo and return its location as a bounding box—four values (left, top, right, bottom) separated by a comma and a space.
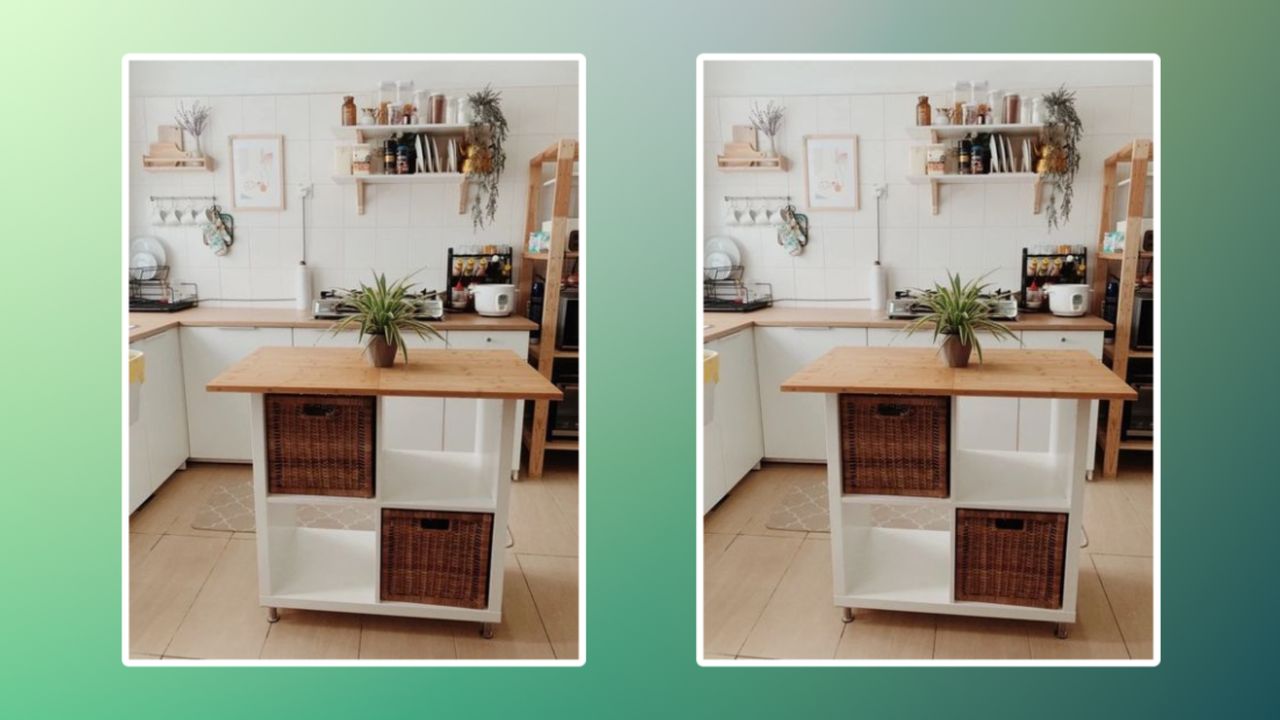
703, 78, 1153, 306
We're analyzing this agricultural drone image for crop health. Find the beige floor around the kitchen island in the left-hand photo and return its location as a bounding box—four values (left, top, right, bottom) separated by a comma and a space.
129, 454, 579, 660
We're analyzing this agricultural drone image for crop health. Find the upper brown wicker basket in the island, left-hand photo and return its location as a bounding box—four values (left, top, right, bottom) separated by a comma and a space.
265, 395, 376, 497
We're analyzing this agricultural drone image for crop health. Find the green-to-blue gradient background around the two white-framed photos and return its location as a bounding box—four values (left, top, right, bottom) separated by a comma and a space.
0, 0, 1280, 717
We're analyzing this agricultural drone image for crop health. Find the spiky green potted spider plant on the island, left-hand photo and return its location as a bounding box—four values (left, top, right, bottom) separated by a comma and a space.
329, 273, 444, 368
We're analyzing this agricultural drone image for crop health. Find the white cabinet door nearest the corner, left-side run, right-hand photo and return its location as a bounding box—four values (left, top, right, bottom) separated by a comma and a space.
708, 329, 764, 492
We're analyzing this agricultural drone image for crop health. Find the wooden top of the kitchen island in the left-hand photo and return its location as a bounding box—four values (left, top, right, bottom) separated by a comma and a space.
206, 347, 563, 400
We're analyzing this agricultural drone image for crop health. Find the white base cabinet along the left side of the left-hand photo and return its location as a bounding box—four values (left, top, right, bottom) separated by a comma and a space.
128, 331, 188, 512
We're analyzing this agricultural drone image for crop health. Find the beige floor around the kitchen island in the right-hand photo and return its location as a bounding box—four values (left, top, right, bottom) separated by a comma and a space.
703, 456, 1152, 660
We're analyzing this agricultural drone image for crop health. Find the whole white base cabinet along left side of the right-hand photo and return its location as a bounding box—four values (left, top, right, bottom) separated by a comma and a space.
703, 329, 764, 512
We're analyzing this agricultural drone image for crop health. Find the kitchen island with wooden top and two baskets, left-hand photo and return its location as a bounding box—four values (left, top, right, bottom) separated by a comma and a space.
207, 347, 561, 637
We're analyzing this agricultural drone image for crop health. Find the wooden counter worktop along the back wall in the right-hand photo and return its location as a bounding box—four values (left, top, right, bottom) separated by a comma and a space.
703, 307, 1111, 342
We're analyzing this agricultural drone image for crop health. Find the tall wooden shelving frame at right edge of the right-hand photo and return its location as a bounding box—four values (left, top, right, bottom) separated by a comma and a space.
1093, 140, 1155, 478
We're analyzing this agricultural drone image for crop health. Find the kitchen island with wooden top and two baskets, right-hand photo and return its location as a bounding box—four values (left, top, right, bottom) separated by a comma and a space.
781, 347, 1135, 637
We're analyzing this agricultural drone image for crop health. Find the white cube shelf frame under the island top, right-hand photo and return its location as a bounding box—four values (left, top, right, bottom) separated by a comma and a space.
827, 393, 1091, 635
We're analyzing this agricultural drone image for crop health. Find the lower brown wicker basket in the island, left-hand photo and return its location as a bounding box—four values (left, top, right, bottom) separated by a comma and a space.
380, 509, 493, 610
